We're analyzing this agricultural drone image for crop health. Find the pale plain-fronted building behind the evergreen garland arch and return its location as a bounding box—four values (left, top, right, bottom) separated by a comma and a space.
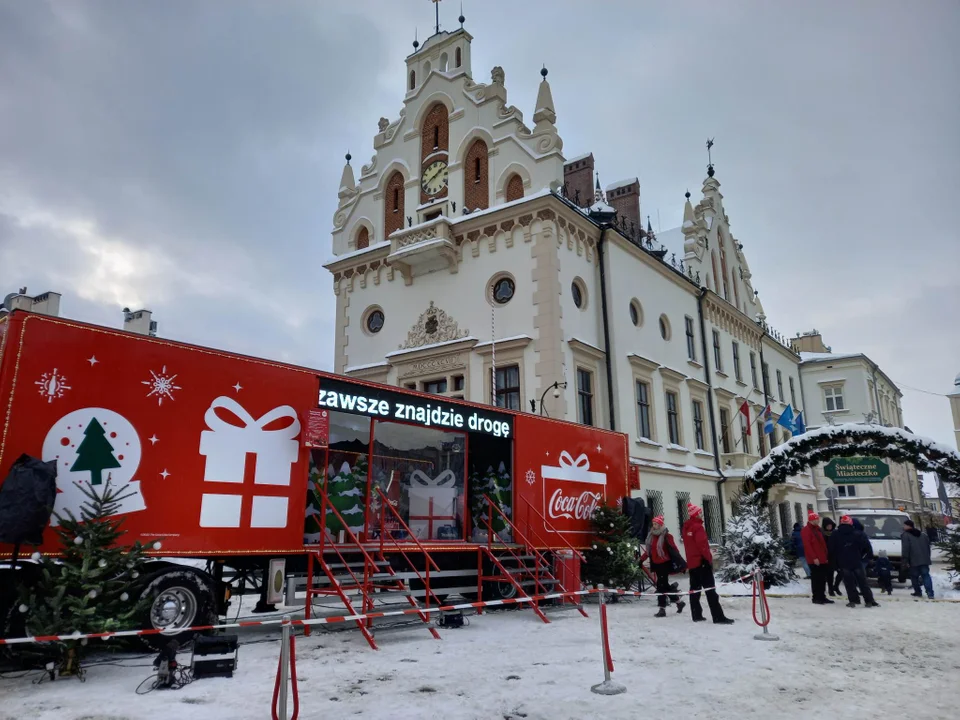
801, 340, 923, 512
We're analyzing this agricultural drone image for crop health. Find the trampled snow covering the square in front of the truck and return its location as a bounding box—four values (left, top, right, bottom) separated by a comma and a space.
0, 586, 960, 720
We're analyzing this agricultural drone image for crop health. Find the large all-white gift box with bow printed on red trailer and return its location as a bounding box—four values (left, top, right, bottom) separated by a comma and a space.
200, 396, 300, 528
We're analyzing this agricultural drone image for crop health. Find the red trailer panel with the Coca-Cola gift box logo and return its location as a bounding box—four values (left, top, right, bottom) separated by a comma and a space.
514, 414, 629, 547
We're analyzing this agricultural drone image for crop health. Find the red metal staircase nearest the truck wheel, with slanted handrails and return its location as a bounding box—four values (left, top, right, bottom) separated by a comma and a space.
304, 485, 440, 650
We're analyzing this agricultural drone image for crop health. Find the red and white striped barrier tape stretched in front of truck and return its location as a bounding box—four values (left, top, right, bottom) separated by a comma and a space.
0, 575, 752, 645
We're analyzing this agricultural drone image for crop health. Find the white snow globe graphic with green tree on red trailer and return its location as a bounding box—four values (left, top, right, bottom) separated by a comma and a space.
43, 408, 147, 527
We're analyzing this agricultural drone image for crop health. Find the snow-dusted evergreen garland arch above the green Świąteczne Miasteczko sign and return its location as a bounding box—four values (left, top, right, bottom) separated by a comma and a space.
743, 423, 960, 496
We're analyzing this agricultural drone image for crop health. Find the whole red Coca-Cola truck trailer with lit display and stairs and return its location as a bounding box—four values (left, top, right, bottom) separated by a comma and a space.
0, 311, 628, 644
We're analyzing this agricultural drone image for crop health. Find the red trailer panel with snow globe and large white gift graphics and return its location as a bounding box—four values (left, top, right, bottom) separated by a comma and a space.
0, 315, 318, 555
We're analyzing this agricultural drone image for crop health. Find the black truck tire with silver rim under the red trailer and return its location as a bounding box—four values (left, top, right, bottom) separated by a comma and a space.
140, 567, 217, 649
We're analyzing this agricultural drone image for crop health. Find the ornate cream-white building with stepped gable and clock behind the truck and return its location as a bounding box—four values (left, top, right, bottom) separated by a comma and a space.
326, 21, 816, 540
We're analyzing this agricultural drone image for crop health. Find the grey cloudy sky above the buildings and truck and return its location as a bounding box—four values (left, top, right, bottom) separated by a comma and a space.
0, 0, 960, 445
